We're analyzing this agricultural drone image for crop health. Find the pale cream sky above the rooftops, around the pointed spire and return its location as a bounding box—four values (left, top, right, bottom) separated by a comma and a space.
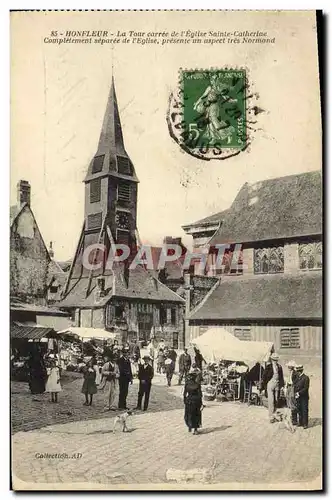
10, 11, 321, 260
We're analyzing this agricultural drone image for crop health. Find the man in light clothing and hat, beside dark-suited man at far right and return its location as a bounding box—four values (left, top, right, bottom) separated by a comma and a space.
262, 353, 285, 423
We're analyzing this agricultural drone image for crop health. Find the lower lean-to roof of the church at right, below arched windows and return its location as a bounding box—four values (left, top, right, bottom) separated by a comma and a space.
189, 271, 323, 321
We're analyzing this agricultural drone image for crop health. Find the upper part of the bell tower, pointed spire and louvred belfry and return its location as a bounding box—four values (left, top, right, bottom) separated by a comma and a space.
84, 78, 139, 250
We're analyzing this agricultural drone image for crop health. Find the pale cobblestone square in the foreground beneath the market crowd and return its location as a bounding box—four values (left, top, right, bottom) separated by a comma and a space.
12, 366, 322, 489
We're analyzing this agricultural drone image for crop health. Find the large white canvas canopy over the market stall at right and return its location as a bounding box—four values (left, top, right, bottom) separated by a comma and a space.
192, 328, 273, 367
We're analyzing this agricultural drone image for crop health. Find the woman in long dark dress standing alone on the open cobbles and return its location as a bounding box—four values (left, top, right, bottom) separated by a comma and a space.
183, 373, 202, 434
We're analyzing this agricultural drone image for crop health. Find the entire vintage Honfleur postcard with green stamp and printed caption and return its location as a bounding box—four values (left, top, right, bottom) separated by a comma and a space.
10, 10, 323, 491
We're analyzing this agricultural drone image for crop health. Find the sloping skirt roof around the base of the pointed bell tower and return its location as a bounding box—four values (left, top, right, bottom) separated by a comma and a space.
57, 264, 184, 308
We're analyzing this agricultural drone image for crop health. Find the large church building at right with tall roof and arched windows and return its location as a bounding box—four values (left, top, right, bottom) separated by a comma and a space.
186, 171, 323, 355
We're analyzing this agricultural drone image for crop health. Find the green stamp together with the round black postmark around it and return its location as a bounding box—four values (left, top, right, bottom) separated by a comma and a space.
167, 68, 263, 160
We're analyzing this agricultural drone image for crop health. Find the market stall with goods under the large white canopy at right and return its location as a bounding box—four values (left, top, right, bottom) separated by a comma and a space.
192, 328, 273, 403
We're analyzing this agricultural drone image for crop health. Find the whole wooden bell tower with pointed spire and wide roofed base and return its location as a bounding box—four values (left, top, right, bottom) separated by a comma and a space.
59, 80, 184, 347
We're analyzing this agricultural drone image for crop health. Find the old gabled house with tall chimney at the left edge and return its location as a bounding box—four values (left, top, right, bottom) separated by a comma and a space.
10, 180, 69, 329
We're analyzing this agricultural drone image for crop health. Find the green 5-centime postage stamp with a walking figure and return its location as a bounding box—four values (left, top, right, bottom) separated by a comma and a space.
182, 69, 246, 150
